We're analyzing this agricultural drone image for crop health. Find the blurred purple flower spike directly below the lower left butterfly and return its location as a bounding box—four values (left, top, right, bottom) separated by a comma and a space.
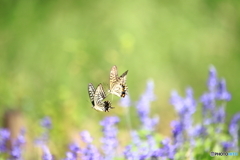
100, 117, 119, 160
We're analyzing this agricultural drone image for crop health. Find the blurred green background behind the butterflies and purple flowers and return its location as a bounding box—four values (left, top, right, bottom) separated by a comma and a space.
0, 0, 240, 158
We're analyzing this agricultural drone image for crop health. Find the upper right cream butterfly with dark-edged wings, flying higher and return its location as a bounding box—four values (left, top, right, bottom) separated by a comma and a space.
108, 66, 128, 97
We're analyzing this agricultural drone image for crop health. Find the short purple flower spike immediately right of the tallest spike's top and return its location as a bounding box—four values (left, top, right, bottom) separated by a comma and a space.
216, 79, 231, 101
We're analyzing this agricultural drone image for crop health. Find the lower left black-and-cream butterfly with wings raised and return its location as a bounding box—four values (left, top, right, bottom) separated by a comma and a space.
88, 83, 113, 112
